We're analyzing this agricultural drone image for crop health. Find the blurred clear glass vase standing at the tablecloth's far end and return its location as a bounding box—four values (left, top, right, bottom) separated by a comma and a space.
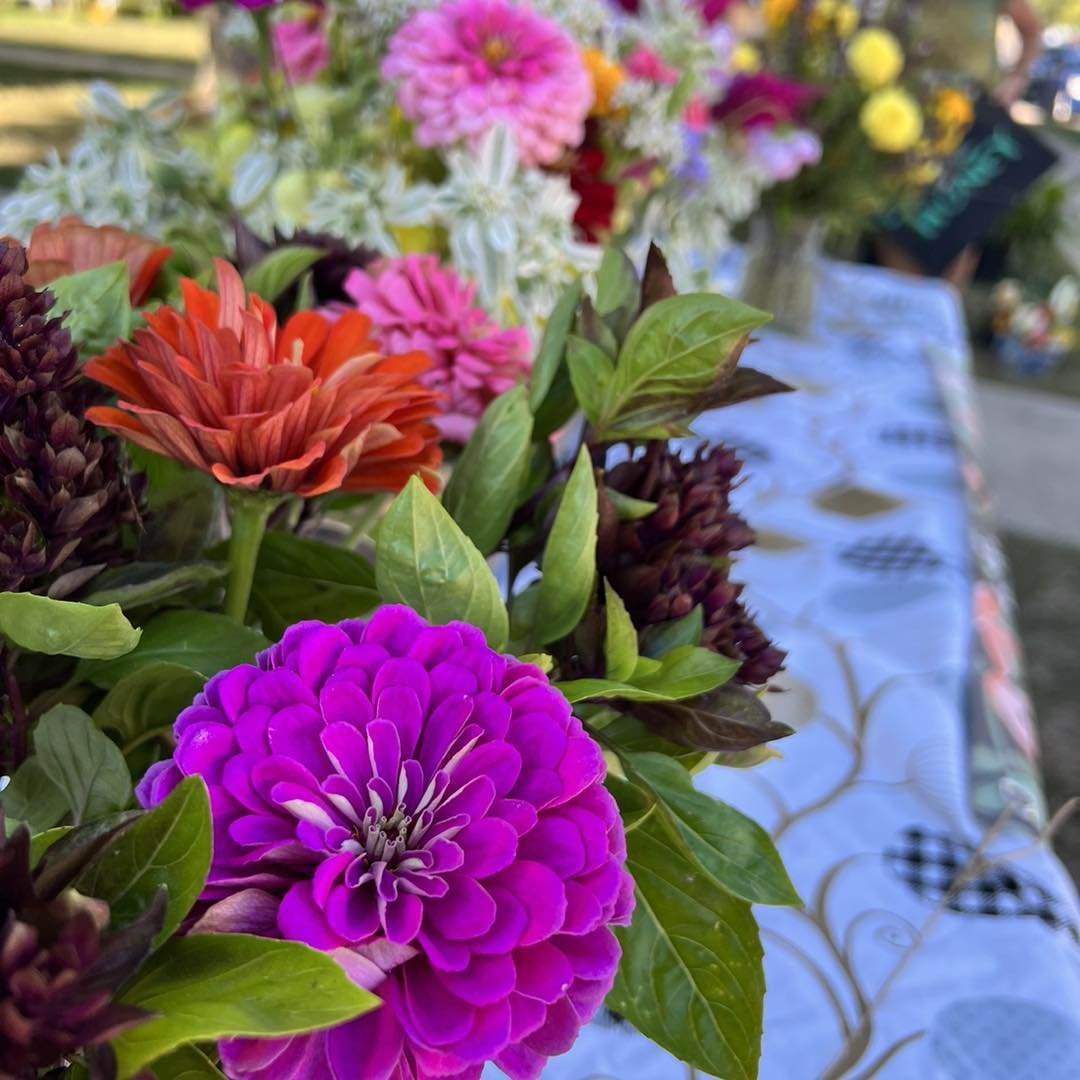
740, 214, 823, 336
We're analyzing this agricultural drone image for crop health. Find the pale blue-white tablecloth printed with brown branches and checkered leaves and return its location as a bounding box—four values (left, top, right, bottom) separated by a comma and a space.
518, 265, 1080, 1080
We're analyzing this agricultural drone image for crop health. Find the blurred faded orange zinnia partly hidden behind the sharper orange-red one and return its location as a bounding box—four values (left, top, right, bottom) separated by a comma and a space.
26, 214, 173, 307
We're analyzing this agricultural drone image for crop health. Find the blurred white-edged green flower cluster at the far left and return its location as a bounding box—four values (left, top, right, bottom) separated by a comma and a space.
0, 83, 208, 240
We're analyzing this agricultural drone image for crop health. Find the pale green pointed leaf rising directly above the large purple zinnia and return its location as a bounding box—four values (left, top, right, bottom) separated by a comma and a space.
375, 476, 510, 649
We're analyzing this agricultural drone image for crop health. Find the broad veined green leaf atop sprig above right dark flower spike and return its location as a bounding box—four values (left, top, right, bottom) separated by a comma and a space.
597, 293, 769, 430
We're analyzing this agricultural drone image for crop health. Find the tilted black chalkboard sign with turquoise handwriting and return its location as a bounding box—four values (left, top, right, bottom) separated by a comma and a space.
882, 98, 1057, 274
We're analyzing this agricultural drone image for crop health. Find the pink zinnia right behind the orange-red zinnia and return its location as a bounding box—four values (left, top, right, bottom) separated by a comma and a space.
345, 255, 531, 443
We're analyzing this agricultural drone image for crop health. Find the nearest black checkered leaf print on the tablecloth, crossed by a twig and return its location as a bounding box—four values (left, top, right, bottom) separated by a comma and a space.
885, 825, 1077, 937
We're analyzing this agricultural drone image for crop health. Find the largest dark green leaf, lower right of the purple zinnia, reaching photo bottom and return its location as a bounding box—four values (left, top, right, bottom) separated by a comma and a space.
607, 777, 765, 1080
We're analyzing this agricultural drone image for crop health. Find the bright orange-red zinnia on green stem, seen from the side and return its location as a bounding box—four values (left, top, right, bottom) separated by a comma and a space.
86, 259, 442, 496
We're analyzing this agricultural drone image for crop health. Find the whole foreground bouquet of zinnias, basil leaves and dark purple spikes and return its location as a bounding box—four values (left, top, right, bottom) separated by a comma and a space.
0, 220, 798, 1080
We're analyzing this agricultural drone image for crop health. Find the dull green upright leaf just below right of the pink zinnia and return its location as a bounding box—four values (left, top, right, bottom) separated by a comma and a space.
443, 387, 532, 555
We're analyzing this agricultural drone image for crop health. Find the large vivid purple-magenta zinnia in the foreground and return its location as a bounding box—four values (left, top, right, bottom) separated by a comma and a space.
138, 607, 633, 1080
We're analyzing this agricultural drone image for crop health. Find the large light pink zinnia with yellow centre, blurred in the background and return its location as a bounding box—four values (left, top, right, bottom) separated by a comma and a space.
382, 0, 593, 165
